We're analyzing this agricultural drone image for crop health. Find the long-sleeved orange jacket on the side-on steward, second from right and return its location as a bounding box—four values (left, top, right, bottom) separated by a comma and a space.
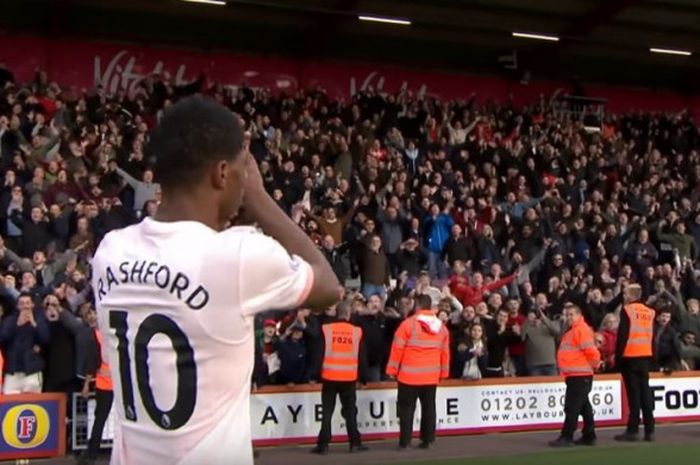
557, 317, 600, 377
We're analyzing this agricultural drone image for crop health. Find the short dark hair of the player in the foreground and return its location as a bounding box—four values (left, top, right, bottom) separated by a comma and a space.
146, 95, 243, 189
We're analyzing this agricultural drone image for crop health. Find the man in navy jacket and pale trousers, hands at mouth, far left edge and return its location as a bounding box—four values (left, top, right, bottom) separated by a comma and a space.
0, 293, 50, 394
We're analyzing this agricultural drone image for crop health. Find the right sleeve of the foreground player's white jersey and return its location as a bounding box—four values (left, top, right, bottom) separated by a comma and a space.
239, 233, 314, 315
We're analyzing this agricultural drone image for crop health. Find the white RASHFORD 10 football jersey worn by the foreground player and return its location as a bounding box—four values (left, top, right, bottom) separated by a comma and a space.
92, 218, 313, 465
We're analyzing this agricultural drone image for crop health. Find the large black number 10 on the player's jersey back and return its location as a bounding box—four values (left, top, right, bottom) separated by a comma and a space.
109, 310, 197, 430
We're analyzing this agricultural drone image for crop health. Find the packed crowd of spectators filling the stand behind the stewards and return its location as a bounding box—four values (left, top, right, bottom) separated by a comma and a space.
0, 61, 700, 392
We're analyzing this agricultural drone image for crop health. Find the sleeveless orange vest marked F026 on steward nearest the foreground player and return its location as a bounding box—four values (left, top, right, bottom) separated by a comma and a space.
321, 322, 362, 381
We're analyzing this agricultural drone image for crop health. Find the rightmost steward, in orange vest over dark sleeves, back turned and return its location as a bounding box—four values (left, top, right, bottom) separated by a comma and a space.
615, 284, 655, 442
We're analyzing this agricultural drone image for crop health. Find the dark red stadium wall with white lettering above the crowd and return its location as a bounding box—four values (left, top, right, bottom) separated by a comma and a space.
0, 35, 700, 114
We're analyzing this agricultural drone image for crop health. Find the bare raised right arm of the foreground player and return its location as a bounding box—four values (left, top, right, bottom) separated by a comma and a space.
243, 153, 340, 310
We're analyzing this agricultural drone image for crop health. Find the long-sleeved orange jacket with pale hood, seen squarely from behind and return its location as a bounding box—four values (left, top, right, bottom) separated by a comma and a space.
386, 310, 450, 386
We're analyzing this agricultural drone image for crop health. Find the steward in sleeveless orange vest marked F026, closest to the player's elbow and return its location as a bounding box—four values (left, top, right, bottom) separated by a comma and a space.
311, 301, 367, 455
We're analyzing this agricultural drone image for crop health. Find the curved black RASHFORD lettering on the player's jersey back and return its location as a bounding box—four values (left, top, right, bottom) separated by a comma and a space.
97, 260, 209, 310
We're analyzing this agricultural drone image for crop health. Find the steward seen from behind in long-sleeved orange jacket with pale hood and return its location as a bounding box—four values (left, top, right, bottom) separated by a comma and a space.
386, 295, 450, 449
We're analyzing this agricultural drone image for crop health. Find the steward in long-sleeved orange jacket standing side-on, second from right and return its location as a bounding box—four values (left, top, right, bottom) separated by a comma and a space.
549, 304, 601, 447
